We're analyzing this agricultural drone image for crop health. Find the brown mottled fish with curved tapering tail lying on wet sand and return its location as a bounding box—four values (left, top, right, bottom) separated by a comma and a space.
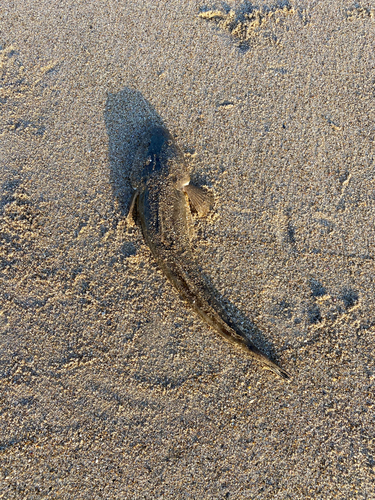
127, 123, 291, 379
